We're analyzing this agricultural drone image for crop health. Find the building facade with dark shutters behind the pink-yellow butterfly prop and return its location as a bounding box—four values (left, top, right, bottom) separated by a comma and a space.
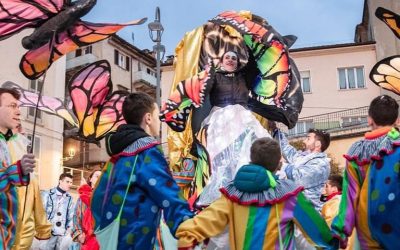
63, 35, 156, 186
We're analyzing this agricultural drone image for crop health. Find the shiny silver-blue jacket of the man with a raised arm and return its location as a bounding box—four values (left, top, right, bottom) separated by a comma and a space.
276, 130, 331, 211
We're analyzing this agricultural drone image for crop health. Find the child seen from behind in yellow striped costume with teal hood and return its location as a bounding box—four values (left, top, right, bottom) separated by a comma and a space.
176, 138, 335, 250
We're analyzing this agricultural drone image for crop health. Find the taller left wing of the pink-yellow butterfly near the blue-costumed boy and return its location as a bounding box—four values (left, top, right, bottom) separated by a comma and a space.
68, 60, 112, 140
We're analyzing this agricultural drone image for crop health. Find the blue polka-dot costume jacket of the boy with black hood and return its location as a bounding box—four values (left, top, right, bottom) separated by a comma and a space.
91, 136, 192, 250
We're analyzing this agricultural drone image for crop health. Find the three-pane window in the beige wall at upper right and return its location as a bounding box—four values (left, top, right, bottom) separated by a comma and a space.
338, 67, 365, 89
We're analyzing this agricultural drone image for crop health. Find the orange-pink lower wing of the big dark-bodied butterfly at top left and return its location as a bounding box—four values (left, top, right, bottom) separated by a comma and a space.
19, 18, 147, 79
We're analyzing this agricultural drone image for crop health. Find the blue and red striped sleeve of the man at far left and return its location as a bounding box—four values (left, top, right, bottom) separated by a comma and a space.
0, 161, 29, 192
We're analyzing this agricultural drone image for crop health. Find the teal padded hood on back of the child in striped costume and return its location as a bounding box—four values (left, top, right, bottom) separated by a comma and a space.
233, 164, 276, 193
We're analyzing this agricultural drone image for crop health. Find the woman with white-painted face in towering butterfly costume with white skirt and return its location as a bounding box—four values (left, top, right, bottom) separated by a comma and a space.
161, 12, 303, 209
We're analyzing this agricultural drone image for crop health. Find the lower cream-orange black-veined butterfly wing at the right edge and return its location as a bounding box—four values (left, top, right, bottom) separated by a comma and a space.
369, 56, 400, 95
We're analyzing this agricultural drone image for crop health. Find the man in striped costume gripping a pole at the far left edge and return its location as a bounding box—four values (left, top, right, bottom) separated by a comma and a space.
0, 88, 35, 250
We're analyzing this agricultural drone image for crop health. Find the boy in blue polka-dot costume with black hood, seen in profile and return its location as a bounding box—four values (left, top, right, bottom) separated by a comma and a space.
91, 93, 192, 250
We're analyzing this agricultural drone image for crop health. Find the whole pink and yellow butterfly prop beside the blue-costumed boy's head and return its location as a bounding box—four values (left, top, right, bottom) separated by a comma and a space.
68, 60, 127, 142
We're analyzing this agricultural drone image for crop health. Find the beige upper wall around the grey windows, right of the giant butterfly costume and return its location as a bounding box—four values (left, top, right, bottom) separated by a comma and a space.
291, 44, 380, 118
